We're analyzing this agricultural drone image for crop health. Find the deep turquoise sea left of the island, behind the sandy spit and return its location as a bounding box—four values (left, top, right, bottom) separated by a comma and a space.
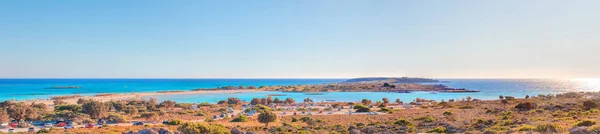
0, 79, 344, 100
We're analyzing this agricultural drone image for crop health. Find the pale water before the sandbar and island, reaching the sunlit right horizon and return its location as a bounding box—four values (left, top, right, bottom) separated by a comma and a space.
146, 79, 600, 103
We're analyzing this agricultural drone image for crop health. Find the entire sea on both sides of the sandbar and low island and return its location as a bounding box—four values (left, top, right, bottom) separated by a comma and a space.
0, 79, 600, 103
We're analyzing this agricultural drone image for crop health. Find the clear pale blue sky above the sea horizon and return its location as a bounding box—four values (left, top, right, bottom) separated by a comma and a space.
0, 0, 600, 78
